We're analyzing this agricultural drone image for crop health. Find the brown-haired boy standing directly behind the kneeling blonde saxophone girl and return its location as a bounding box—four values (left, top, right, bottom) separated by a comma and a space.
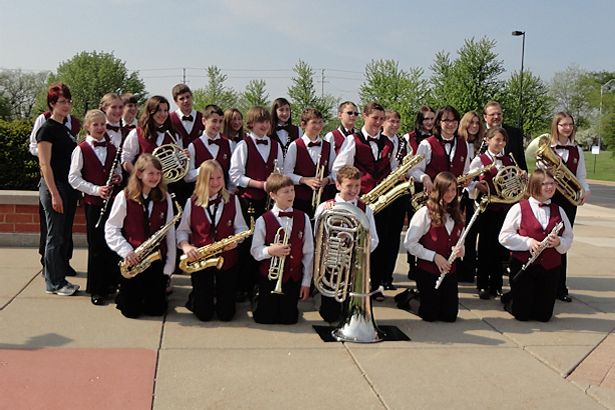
184, 104, 234, 183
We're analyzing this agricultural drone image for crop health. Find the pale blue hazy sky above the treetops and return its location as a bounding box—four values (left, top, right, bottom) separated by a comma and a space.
0, 0, 615, 105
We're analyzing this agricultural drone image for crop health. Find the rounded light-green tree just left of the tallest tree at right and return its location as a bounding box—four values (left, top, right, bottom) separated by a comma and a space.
359, 60, 429, 132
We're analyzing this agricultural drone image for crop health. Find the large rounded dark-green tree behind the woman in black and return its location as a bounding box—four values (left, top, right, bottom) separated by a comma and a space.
43, 51, 146, 116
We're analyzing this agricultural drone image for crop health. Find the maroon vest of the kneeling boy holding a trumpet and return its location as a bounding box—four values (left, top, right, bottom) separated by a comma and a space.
260, 209, 305, 283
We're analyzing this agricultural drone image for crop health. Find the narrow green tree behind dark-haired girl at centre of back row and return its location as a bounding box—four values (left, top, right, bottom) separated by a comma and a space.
288, 60, 338, 123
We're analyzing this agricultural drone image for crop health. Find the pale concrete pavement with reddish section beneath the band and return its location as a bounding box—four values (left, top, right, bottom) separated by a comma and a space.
0, 205, 615, 410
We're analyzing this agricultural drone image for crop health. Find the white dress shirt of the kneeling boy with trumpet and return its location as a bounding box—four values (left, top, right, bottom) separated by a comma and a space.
250, 205, 314, 287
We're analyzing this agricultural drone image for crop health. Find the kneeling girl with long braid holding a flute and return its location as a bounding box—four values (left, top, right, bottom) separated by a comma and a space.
404, 172, 464, 322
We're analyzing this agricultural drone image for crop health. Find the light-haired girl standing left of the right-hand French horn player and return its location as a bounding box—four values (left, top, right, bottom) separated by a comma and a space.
457, 111, 485, 283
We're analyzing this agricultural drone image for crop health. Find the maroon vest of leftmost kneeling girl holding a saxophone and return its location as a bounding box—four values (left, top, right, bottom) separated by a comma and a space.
122, 195, 168, 260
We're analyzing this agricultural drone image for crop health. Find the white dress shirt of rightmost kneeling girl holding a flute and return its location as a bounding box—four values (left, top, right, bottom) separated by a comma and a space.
498, 197, 573, 254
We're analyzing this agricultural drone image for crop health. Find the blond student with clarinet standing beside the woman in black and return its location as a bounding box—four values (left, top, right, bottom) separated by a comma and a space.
68, 110, 122, 305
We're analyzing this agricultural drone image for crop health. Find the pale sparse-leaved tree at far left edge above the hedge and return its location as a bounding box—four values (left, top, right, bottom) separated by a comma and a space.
0, 70, 49, 119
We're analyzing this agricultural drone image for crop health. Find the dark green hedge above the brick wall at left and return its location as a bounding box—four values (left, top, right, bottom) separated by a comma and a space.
0, 120, 40, 191
